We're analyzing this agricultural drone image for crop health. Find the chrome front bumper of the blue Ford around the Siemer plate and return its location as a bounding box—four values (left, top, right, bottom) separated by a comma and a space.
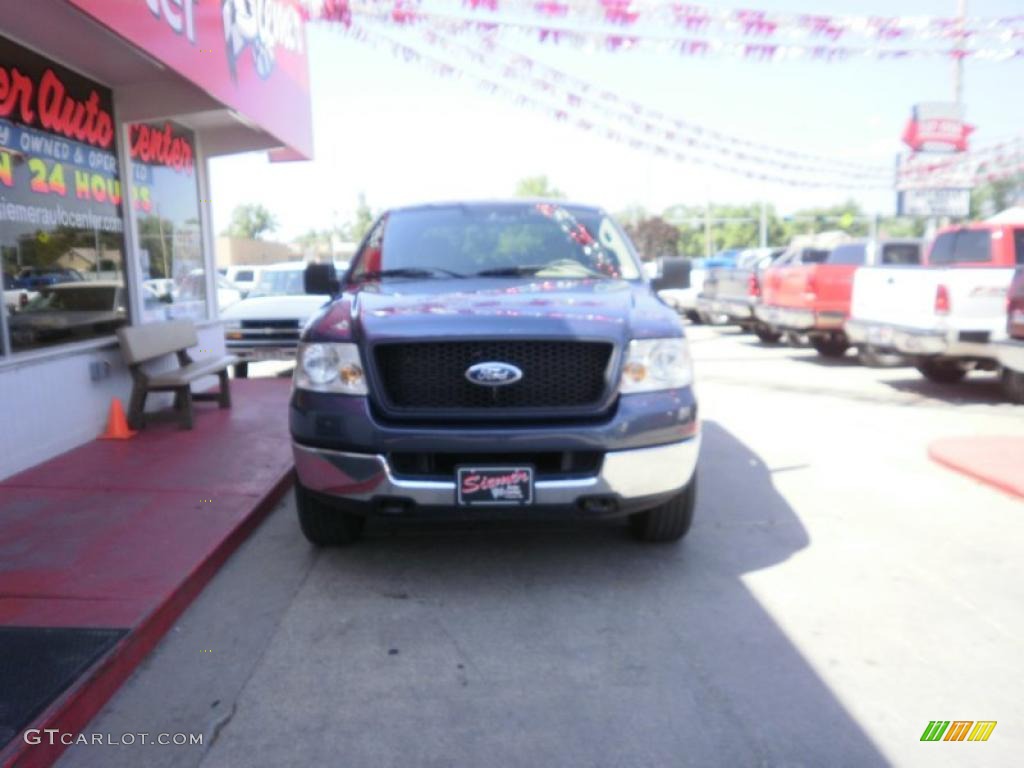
292, 434, 700, 507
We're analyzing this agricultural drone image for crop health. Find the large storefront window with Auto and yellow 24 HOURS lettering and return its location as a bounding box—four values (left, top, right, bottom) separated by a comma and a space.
0, 33, 128, 354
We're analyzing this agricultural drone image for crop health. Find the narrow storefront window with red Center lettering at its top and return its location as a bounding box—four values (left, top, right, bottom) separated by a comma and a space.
128, 121, 209, 323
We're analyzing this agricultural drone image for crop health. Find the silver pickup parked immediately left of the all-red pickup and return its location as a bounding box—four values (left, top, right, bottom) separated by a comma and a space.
697, 248, 785, 341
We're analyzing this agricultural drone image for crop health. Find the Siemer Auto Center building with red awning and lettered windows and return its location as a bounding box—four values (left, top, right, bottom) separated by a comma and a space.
0, 0, 312, 478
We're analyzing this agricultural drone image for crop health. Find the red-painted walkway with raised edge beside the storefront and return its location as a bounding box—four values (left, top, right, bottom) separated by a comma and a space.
0, 379, 292, 767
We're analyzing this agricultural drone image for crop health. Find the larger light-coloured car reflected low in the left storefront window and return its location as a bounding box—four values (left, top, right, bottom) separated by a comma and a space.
7, 281, 128, 347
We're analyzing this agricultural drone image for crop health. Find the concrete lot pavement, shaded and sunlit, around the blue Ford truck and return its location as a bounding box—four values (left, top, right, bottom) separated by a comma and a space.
59, 328, 1024, 768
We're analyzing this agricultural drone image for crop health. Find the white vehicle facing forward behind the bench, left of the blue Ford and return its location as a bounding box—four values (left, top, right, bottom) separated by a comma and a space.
220, 261, 330, 378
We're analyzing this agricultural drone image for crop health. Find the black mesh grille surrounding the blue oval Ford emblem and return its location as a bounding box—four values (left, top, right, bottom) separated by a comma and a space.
376, 341, 611, 410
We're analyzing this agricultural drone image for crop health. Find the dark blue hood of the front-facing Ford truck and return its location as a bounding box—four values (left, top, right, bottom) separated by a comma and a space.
308, 278, 682, 344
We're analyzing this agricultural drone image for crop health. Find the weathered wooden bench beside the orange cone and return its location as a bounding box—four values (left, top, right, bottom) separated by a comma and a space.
118, 319, 239, 429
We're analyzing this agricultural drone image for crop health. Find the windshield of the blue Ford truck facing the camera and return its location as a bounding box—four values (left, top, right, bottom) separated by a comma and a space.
349, 203, 640, 281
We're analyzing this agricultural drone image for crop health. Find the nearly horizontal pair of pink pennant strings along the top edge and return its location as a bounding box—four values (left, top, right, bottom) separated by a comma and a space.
310, 0, 1024, 61
